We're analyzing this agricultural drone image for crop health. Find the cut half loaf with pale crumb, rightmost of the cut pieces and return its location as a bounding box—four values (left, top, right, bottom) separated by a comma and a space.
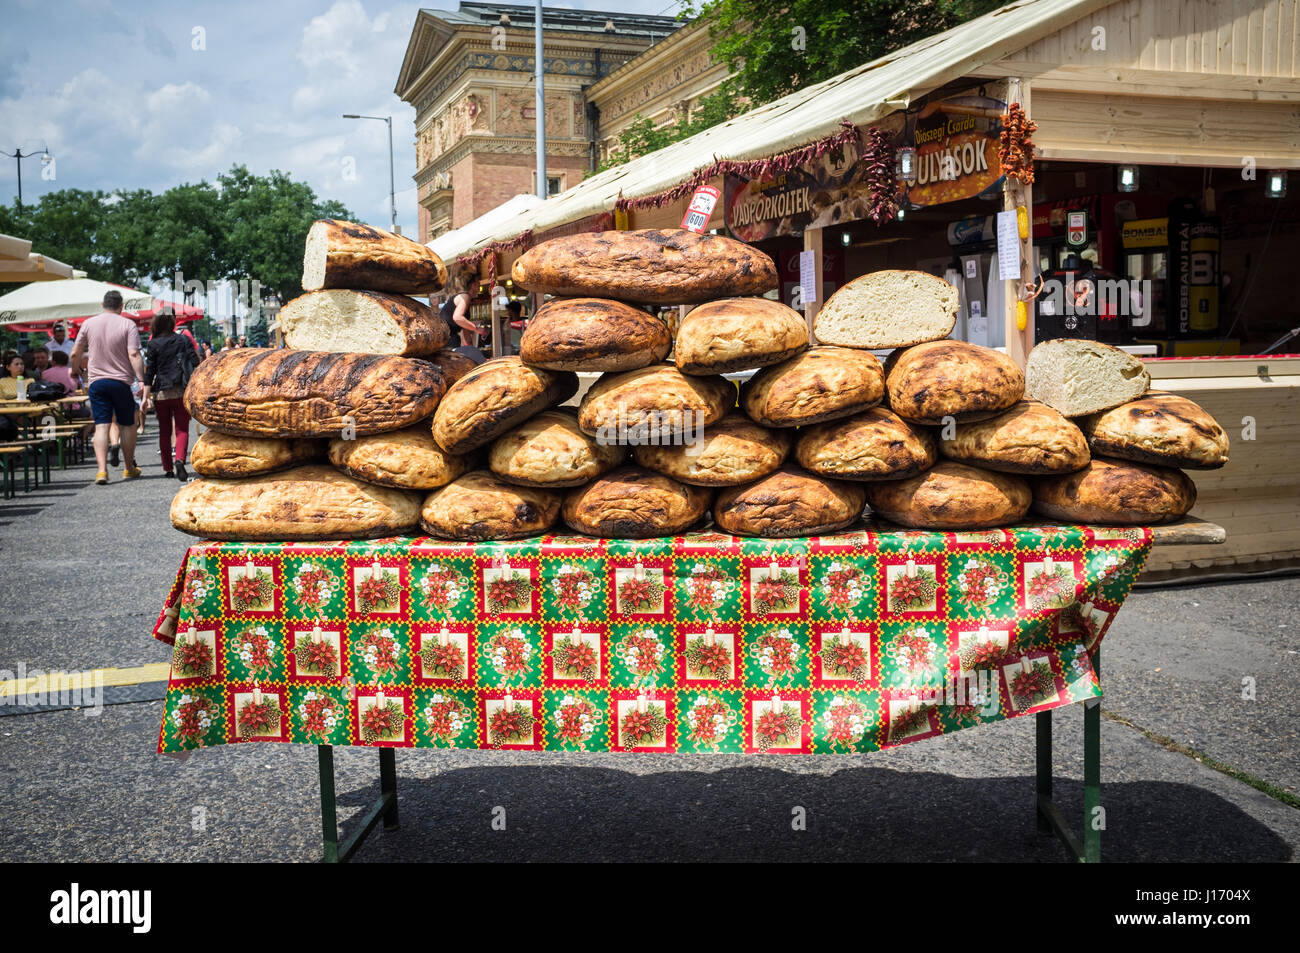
1024, 338, 1151, 417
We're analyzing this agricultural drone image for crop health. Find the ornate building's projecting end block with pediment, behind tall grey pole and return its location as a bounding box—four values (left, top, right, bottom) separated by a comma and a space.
395, 3, 680, 242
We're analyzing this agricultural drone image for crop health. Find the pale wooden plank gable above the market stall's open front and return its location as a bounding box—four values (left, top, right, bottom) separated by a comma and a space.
1006, 0, 1300, 77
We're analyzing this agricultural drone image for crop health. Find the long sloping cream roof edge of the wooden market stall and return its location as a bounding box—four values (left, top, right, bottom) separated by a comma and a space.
438, 0, 1115, 260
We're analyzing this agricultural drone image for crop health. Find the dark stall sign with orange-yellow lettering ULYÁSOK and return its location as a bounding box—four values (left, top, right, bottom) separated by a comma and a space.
901, 94, 1006, 205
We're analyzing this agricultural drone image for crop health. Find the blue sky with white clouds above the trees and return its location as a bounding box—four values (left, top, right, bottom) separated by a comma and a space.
0, 0, 676, 234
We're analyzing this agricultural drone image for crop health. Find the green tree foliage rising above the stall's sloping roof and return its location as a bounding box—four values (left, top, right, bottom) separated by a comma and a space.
684, 0, 1006, 105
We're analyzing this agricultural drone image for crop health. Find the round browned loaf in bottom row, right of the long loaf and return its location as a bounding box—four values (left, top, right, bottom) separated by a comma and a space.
420, 469, 560, 540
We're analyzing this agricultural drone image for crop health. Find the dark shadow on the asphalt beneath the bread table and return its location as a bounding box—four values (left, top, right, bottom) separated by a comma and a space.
338, 766, 1291, 862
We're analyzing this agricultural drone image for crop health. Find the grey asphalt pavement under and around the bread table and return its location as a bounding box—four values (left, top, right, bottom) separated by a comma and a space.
0, 447, 1300, 862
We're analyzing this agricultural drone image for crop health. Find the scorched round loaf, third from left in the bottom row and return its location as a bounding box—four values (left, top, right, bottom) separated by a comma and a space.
564, 467, 712, 540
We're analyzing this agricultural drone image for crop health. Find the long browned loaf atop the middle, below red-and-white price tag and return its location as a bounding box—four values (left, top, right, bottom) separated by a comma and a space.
511, 229, 777, 304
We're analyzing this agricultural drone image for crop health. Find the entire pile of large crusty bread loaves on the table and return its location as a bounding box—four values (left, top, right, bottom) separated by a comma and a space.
172, 221, 1227, 540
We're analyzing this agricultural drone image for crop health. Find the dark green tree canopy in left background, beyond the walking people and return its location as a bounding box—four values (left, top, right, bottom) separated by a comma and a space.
0, 165, 352, 299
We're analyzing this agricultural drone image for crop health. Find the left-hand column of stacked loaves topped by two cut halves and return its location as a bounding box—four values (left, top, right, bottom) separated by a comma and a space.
172, 220, 472, 541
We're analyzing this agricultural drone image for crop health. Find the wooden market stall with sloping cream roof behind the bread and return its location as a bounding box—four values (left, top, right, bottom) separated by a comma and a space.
439, 0, 1300, 577
